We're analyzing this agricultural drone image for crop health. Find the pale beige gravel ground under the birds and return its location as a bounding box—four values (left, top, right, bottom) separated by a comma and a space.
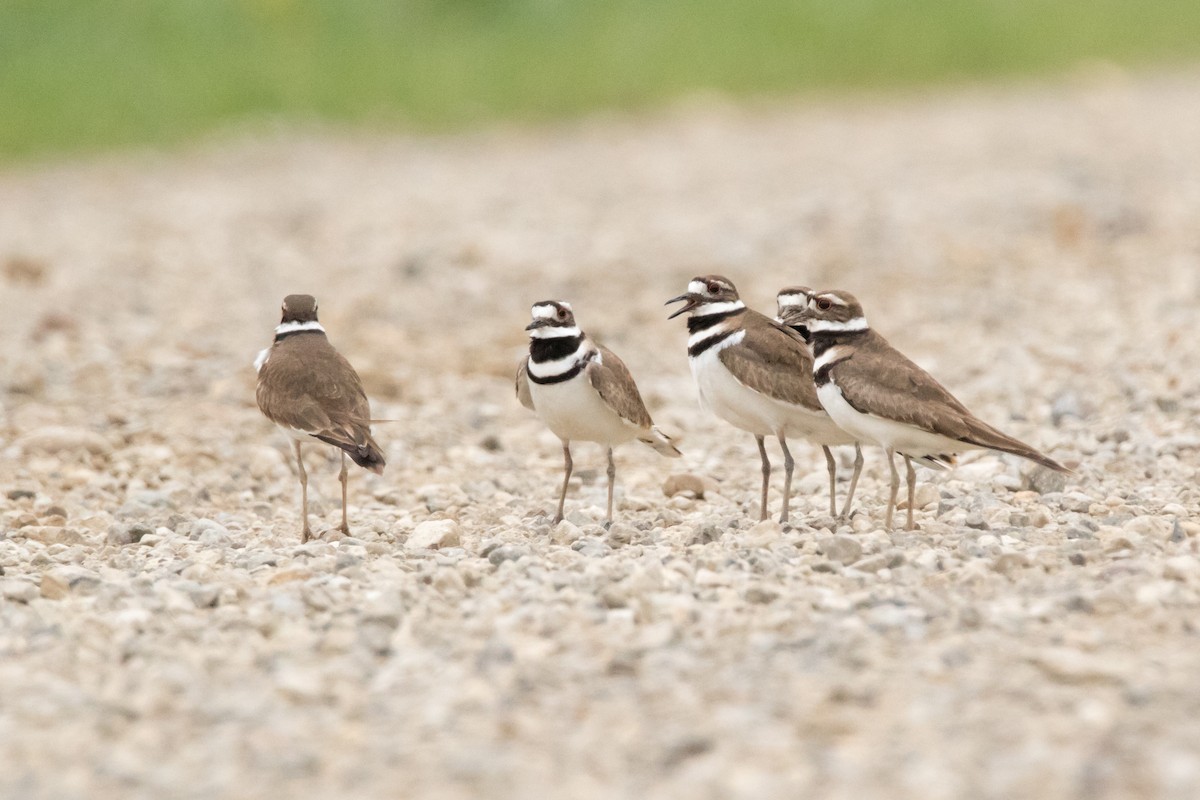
0, 74, 1200, 800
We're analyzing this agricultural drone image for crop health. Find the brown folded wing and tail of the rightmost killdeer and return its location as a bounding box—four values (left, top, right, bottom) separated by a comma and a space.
832, 331, 1066, 471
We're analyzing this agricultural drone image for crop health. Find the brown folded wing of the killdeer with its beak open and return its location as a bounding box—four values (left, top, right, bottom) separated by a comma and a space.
718, 311, 821, 410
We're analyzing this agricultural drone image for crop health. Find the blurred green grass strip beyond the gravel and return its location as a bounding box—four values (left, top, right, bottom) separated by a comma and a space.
0, 0, 1200, 162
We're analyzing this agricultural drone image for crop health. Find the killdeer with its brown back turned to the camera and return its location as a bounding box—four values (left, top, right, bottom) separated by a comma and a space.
254, 294, 384, 541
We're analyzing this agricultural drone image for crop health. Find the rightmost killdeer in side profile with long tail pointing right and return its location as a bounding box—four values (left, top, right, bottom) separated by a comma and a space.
781, 288, 1070, 530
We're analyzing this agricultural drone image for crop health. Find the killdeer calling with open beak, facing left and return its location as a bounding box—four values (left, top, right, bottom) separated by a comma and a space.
667, 275, 854, 523
